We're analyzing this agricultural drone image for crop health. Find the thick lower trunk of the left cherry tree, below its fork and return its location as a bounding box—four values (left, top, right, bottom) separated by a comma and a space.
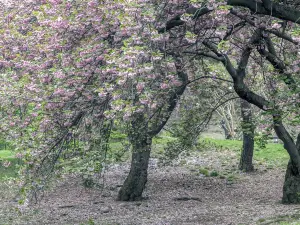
118, 138, 151, 201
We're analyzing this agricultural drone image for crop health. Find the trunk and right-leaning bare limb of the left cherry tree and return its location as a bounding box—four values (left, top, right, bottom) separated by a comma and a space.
117, 56, 188, 201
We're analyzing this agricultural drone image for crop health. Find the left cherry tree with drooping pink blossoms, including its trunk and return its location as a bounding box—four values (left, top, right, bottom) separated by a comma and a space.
1, 0, 192, 200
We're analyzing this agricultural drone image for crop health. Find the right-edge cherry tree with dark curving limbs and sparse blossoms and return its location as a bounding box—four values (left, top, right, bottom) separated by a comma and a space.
161, 0, 300, 203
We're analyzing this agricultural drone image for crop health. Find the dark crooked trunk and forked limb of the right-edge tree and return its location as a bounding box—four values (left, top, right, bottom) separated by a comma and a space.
195, 19, 300, 204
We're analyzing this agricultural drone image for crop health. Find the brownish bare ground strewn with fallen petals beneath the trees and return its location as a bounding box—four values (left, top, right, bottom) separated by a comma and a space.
0, 152, 300, 225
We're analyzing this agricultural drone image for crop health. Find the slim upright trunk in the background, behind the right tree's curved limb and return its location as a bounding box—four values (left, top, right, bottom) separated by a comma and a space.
239, 99, 255, 172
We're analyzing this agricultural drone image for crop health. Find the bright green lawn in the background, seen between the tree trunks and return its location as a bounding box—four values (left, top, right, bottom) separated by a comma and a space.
0, 136, 289, 180
